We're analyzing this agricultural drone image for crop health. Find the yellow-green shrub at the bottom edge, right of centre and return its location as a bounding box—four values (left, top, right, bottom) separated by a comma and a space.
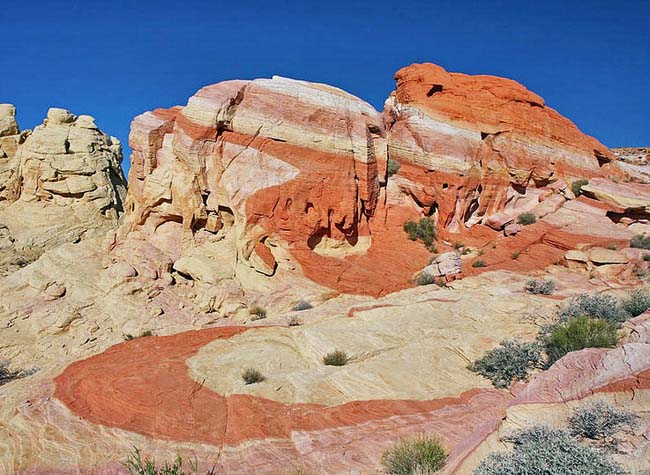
381, 435, 448, 475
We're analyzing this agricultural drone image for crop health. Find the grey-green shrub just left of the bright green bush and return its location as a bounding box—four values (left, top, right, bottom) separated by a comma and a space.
469, 340, 541, 388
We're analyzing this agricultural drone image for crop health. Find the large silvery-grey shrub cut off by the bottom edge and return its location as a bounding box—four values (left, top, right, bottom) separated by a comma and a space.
474, 426, 625, 475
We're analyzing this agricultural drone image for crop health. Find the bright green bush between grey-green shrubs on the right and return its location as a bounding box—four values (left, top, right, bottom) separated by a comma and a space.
543, 317, 618, 365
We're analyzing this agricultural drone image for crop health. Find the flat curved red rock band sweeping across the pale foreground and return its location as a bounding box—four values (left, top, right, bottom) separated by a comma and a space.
54, 327, 511, 454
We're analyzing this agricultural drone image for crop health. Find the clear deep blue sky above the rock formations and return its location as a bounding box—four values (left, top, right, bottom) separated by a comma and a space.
0, 0, 650, 175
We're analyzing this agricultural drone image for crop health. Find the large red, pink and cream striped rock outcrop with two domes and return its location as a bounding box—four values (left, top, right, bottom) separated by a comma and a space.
118, 64, 623, 295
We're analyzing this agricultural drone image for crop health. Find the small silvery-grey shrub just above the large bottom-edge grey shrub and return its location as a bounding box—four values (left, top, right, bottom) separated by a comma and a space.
569, 400, 636, 439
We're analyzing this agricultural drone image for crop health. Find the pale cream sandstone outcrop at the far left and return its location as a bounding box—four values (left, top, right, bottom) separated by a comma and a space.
0, 104, 126, 276
